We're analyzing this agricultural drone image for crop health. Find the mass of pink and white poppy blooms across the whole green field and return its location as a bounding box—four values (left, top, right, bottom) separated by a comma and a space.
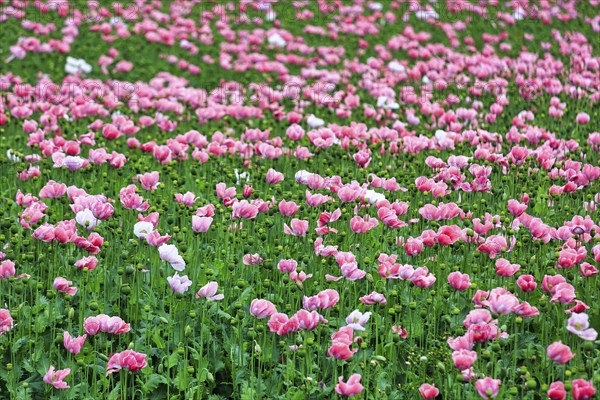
0, 0, 600, 400
